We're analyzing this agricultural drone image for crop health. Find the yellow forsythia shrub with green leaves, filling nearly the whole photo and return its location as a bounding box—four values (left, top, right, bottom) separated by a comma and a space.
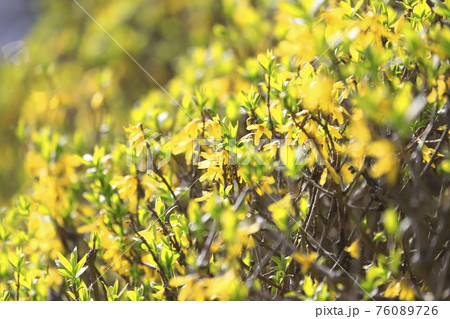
0, 0, 450, 300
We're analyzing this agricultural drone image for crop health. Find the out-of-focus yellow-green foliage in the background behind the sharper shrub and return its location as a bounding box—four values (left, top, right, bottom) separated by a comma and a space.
0, 0, 217, 204
